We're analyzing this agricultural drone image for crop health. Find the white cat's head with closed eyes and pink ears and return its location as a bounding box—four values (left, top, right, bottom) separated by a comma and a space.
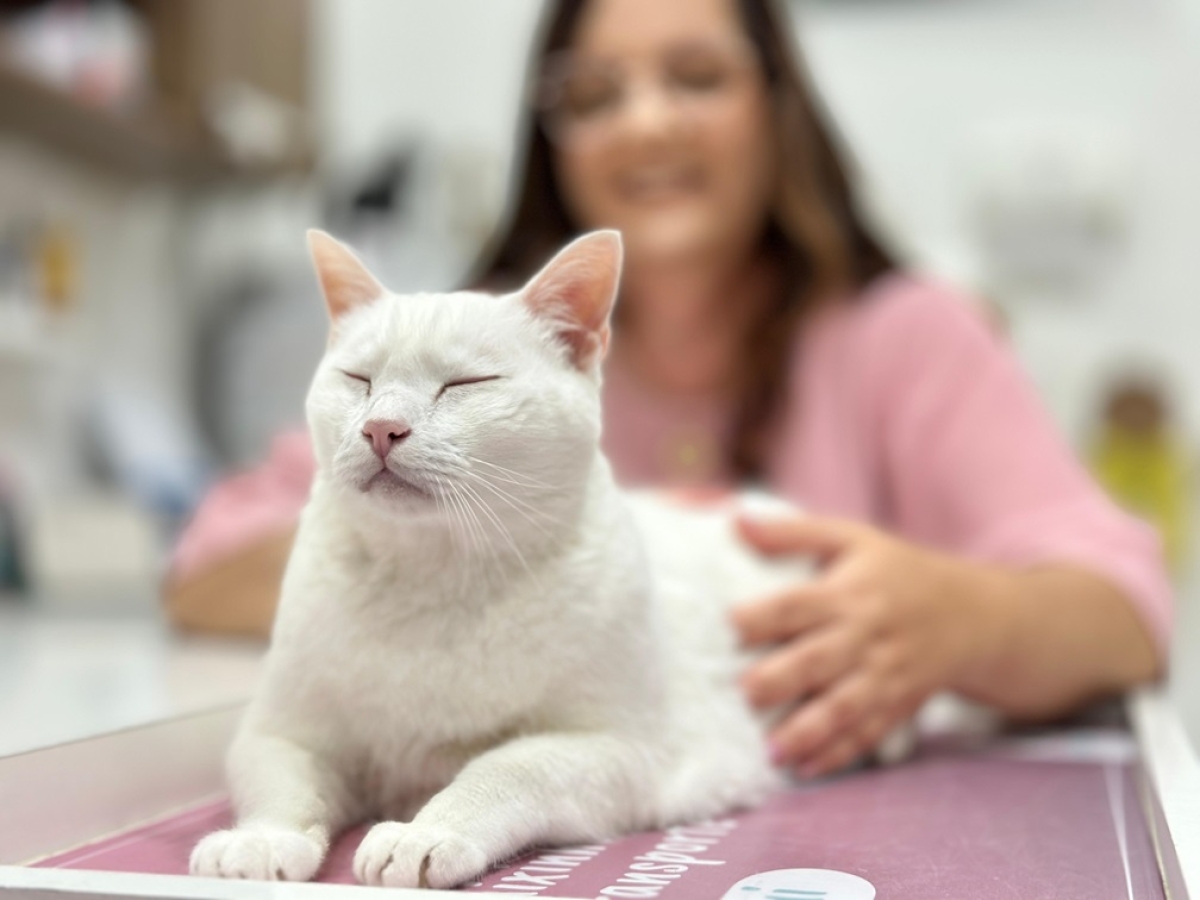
307, 232, 622, 533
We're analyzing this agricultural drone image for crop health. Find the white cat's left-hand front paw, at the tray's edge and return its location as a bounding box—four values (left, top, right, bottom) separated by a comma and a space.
188, 826, 325, 881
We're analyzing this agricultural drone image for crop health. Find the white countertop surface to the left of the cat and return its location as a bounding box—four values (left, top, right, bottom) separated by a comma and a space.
0, 601, 265, 756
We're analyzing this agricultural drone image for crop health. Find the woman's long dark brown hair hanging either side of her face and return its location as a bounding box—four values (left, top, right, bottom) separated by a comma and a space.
473, 0, 894, 480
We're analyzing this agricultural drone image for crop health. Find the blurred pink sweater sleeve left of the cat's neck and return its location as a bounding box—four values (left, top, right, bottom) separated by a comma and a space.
170, 432, 316, 577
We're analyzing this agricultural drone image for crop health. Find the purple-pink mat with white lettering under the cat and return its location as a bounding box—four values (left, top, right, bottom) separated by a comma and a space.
36, 755, 1164, 900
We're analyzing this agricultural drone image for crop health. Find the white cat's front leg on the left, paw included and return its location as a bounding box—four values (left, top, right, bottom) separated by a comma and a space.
190, 733, 356, 881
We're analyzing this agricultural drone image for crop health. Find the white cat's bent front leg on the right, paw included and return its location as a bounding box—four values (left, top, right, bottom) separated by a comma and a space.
354, 733, 659, 888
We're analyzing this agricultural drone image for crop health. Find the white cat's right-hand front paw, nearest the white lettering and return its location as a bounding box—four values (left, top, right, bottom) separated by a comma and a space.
354, 822, 491, 888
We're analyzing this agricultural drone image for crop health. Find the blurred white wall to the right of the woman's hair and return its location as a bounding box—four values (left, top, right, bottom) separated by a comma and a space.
798, 0, 1200, 434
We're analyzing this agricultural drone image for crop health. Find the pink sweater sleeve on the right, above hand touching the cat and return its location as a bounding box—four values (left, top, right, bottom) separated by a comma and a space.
865, 282, 1172, 650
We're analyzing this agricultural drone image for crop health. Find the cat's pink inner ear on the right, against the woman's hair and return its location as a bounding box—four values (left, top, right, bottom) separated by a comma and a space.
521, 230, 622, 370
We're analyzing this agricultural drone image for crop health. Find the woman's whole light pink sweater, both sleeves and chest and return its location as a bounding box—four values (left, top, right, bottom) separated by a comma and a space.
174, 276, 1172, 648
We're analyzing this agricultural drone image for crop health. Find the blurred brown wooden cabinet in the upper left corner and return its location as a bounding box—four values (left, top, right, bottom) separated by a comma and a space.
0, 0, 312, 181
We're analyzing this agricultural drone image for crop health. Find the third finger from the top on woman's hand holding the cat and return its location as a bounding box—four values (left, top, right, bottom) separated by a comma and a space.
742, 625, 865, 709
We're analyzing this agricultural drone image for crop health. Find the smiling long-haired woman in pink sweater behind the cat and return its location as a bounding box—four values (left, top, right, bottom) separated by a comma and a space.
170, 0, 1170, 774
